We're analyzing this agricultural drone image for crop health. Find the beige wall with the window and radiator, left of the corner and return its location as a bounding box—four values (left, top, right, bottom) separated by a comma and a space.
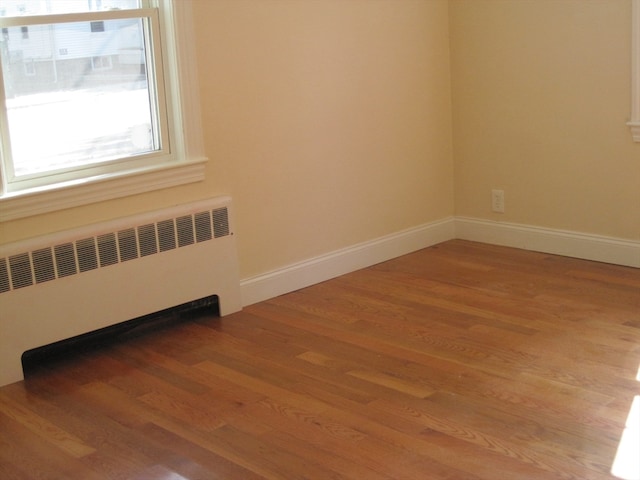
0, 0, 453, 278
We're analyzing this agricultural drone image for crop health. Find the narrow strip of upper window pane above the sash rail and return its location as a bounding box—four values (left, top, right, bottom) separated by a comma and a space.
0, 0, 142, 17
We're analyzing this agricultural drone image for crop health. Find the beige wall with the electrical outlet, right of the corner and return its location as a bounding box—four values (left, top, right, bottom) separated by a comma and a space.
450, 0, 640, 240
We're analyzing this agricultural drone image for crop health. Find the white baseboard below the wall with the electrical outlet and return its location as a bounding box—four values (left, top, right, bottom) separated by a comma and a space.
455, 217, 640, 268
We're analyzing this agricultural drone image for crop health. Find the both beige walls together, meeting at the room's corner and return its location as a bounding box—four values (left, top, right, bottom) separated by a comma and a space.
0, 0, 640, 284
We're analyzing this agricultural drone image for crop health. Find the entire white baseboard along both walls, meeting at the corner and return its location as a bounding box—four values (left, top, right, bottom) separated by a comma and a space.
240, 217, 640, 306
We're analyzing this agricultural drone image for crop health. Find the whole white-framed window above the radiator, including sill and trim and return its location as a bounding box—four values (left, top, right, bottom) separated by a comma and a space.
0, 0, 206, 220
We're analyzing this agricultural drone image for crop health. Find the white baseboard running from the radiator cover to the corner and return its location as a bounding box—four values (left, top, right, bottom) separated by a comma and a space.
240, 217, 454, 306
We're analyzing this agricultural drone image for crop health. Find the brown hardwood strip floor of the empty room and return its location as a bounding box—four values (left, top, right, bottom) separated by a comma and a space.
0, 241, 640, 480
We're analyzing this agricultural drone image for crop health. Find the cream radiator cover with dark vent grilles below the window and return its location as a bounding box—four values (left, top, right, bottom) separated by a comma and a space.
0, 197, 241, 385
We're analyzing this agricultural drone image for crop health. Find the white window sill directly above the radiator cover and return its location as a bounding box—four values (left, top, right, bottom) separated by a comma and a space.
0, 158, 207, 222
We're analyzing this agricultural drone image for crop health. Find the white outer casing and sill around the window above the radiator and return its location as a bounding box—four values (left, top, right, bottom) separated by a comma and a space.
0, 0, 208, 222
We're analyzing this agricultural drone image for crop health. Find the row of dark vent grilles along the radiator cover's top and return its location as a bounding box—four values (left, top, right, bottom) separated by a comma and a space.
0, 207, 231, 294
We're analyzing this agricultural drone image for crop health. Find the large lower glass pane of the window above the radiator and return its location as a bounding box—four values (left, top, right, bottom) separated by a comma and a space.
0, 18, 160, 178
